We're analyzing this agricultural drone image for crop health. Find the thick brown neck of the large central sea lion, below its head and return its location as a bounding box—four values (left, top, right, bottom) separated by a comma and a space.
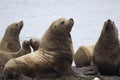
39, 30, 72, 51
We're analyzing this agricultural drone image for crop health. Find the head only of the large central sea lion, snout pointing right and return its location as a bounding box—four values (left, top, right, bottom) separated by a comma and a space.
50, 18, 74, 35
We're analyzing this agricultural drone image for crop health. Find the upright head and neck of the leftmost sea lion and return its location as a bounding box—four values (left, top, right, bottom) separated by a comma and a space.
0, 21, 23, 52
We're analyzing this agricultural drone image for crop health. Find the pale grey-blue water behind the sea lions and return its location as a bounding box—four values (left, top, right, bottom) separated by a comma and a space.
0, 0, 120, 52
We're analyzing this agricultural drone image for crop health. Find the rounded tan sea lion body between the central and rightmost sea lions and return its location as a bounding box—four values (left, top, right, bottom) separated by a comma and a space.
74, 45, 95, 68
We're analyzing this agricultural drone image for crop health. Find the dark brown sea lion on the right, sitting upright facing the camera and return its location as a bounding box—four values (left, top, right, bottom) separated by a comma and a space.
86, 19, 120, 76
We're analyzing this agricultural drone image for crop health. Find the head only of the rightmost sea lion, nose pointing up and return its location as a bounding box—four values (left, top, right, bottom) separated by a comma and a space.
100, 19, 118, 44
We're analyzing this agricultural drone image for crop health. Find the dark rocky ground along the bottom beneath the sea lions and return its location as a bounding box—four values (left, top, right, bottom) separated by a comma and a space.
0, 66, 120, 80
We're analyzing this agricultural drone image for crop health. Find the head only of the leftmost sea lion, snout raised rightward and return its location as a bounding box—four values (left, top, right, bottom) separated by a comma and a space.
6, 21, 23, 37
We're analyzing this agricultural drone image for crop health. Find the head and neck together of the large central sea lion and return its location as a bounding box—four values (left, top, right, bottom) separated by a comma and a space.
39, 18, 74, 51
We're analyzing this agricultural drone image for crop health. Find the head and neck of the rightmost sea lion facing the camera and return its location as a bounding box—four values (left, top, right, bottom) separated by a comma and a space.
96, 20, 119, 49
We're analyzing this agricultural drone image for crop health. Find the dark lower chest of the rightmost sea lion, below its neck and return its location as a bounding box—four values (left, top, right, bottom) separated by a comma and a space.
94, 51, 120, 75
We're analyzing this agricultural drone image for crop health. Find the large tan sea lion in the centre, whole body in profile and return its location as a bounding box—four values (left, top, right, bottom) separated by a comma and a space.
4, 18, 74, 78
